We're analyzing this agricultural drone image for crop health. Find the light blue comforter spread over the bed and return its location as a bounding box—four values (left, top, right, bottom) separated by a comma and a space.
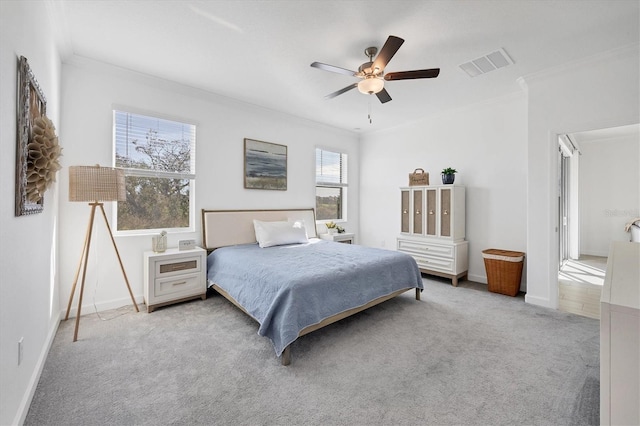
207, 240, 423, 356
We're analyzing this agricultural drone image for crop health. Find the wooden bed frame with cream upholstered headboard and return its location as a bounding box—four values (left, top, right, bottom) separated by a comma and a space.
202, 208, 420, 365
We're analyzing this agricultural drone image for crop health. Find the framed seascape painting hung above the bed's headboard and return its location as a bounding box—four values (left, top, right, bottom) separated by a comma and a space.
244, 138, 287, 191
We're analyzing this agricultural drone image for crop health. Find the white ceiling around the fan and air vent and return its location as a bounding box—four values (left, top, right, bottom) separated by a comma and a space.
47, 0, 640, 132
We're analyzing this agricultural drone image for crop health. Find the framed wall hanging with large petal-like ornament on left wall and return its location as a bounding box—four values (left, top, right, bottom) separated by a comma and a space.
16, 56, 62, 216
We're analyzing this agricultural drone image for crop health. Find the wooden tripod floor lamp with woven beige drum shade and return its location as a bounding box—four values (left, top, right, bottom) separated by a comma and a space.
64, 165, 140, 342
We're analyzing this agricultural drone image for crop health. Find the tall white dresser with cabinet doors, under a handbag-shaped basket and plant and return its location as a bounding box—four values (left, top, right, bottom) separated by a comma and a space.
398, 185, 469, 286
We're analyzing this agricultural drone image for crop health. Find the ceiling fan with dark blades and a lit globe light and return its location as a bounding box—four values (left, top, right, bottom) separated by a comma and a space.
311, 36, 440, 103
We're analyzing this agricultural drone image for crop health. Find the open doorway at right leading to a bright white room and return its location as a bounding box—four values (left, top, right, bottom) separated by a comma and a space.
557, 124, 640, 318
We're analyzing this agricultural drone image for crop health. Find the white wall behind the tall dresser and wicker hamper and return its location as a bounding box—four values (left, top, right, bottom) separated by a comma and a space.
360, 93, 527, 289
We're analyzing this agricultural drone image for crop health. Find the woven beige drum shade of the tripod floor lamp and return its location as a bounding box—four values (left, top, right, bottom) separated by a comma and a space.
69, 165, 127, 202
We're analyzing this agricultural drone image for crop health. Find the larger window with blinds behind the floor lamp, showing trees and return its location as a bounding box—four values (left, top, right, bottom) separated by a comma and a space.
113, 111, 196, 231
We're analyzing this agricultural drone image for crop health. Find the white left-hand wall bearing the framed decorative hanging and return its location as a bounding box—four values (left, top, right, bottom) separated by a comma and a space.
0, 0, 64, 425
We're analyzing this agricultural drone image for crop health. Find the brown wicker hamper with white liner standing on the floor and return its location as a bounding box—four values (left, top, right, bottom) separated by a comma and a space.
482, 249, 524, 296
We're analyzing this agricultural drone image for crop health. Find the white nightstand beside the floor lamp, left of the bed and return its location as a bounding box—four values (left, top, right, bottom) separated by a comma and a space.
144, 247, 207, 312
